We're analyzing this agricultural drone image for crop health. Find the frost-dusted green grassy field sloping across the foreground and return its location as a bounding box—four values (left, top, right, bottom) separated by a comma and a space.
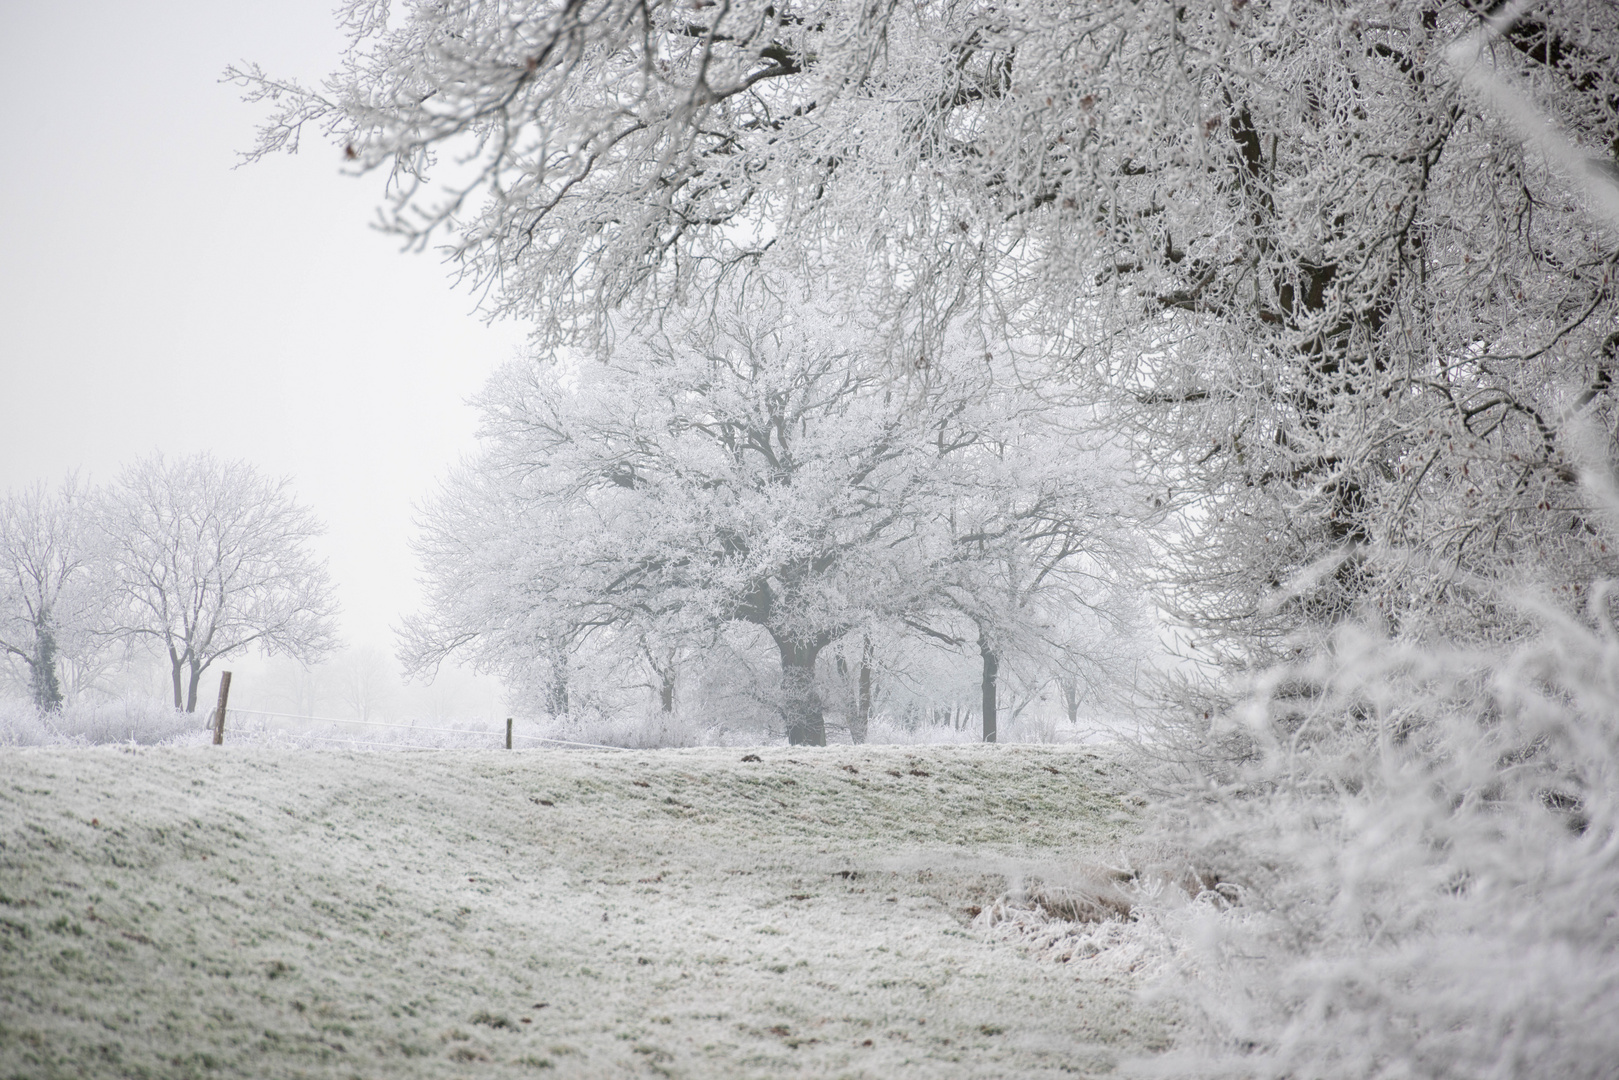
0, 746, 1167, 1080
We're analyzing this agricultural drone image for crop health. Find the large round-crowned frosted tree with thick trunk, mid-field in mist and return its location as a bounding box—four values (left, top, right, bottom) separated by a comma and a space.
408, 309, 958, 743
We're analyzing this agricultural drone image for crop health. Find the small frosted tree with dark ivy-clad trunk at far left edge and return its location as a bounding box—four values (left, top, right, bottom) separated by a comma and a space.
0, 476, 108, 711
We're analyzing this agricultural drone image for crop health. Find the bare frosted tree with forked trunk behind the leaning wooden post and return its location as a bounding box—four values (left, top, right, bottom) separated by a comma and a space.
102, 453, 337, 712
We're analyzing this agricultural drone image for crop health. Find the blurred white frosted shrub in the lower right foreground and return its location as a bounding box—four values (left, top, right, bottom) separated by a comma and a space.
1154, 585, 1619, 1080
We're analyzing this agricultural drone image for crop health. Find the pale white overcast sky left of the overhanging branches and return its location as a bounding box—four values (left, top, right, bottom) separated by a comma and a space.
0, 0, 525, 663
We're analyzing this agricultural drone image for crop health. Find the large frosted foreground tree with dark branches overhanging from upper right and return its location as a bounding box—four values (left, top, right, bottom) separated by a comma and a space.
240, 0, 1619, 662
